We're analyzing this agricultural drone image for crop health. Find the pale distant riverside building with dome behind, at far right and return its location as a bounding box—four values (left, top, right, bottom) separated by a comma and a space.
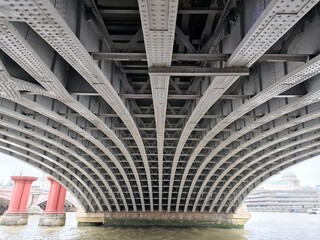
245, 171, 320, 212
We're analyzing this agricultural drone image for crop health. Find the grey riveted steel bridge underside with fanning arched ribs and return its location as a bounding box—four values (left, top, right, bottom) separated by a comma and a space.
0, 0, 320, 227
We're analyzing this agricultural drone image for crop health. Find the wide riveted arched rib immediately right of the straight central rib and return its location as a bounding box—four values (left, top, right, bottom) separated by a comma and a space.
169, 0, 316, 211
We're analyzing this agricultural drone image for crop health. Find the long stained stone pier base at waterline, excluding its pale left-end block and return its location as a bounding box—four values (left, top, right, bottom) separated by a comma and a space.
104, 212, 250, 228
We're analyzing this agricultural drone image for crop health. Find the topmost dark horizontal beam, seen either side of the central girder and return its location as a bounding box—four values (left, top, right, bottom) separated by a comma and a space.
100, 7, 222, 17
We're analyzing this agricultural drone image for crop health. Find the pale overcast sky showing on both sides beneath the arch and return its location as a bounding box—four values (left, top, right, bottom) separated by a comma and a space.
0, 153, 320, 187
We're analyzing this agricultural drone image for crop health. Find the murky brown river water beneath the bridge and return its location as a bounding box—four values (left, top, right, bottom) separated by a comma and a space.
0, 213, 320, 240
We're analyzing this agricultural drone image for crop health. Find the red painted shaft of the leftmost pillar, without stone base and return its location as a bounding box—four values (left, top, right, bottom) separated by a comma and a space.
6, 176, 38, 214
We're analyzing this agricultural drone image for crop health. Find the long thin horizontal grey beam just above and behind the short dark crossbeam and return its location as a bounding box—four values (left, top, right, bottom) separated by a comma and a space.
91, 52, 312, 62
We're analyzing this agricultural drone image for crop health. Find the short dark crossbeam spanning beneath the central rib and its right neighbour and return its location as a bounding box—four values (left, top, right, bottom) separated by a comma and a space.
149, 67, 249, 76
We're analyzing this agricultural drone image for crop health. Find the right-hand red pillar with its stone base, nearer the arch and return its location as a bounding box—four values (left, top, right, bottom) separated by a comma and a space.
39, 177, 67, 226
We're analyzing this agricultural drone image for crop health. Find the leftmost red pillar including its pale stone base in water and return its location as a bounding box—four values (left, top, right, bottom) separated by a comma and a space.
0, 176, 38, 226
